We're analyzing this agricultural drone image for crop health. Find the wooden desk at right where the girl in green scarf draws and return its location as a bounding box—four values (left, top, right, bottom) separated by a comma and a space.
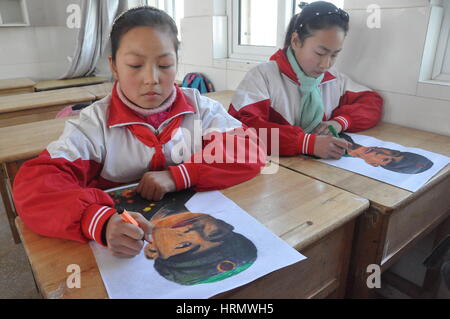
279, 123, 450, 298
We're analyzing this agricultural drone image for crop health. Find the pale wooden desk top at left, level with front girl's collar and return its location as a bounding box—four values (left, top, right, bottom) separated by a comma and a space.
0, 88, 95, 113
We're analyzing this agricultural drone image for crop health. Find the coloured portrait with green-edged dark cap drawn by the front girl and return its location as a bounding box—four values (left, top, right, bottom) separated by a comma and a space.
144, 209, 257, 285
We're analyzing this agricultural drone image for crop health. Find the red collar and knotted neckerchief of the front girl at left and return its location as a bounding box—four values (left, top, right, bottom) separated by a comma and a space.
108, 85, 195, 171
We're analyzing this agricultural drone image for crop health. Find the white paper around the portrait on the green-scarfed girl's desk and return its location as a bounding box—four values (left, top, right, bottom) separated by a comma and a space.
319, 133, 450, 192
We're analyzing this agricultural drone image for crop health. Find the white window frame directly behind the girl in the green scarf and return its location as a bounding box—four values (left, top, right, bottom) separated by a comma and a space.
227, 0, 294, 61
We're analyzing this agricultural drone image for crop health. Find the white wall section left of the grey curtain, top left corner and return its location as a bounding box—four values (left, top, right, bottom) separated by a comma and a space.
0, 0, 80, 80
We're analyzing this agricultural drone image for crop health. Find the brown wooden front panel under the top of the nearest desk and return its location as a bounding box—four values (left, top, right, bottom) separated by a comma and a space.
216, 221, 354, 299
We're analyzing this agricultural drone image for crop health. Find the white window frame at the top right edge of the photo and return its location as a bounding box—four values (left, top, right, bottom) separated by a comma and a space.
420, 0, 450, 86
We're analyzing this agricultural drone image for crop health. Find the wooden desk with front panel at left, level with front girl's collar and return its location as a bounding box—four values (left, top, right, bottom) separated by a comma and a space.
0, 88, 95, 128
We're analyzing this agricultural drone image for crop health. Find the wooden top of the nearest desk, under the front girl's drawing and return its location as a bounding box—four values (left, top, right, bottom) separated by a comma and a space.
16, 167, 369, 298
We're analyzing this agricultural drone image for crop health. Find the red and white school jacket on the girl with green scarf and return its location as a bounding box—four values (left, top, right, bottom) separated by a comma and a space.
229, 49, 383, 156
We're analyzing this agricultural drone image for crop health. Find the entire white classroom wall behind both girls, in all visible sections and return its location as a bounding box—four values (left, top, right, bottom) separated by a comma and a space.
0, 0, 450, 135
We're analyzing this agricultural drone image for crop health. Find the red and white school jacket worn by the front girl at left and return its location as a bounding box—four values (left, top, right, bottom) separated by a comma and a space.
13, 84, 265, 245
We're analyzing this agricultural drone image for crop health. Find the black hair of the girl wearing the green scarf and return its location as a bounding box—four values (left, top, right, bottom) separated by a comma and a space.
284, 1, 349, 47
